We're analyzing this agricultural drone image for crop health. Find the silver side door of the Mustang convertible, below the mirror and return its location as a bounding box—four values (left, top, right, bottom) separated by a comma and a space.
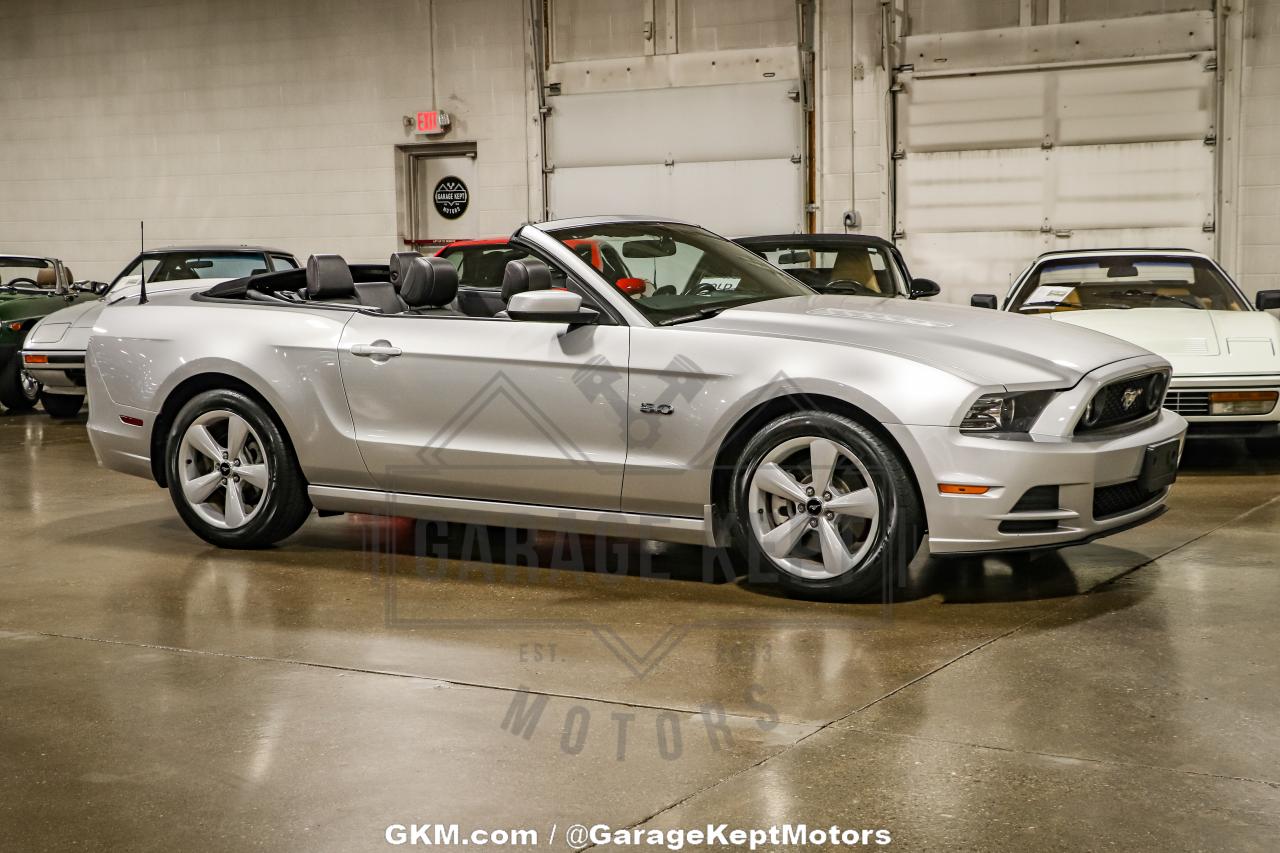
339, 314, 628, 510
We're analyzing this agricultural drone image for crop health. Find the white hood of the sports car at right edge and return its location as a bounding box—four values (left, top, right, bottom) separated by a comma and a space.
1042, 307, 1280, 375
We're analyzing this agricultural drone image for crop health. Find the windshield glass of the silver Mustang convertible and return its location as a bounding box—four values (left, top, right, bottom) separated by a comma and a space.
552, 223, 813, 323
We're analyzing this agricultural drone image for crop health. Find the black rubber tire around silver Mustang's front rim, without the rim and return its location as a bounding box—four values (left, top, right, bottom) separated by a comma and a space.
730, 412, 919, 599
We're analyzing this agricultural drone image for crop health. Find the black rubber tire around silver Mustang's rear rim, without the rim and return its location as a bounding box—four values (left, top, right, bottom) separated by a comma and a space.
164, 389, 301, 548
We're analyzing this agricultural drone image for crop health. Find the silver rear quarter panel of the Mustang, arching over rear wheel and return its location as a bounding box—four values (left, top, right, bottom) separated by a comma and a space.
88, 296, 372, 487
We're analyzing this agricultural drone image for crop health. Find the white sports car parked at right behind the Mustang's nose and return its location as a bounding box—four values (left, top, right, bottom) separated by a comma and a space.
973, 248, 1280, 451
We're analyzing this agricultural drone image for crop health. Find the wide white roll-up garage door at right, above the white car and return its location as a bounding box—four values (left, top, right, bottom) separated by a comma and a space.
895, 19, 1216, 302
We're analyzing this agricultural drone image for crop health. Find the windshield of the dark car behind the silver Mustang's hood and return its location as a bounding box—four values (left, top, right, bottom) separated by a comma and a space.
745, 237, 908, 297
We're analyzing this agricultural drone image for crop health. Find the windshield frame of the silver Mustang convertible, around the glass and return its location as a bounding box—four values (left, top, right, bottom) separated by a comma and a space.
532, 216, 818, 327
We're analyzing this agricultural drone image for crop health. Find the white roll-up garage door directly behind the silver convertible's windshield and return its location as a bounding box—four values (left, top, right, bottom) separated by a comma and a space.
547, 77, 805, 237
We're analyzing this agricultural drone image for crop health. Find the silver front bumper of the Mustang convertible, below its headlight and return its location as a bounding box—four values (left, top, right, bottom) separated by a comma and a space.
891, 410, 1187, 555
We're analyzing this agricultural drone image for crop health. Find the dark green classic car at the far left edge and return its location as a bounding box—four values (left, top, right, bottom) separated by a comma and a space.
0, 255, 99, 411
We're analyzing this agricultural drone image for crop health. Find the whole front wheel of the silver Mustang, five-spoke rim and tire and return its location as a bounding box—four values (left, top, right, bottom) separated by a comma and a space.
732, 411, 923, 601
